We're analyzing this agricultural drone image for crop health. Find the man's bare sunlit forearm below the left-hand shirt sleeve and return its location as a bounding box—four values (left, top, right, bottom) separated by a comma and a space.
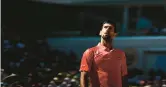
80, 72, 88, 87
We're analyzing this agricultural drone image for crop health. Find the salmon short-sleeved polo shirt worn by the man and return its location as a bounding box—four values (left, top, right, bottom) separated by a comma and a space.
80, 43, 127, 87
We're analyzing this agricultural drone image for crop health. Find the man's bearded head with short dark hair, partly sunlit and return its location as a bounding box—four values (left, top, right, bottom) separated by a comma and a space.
100, 23, 115, 39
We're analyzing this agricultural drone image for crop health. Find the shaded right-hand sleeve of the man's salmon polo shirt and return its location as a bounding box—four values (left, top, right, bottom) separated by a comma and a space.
122, 53, 128, 76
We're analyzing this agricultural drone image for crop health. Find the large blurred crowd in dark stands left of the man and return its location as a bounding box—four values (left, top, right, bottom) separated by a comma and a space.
1, 36, 78, 87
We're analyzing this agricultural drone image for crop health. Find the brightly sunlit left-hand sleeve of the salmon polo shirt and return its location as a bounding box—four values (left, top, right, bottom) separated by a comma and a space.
80, 49, 93, 72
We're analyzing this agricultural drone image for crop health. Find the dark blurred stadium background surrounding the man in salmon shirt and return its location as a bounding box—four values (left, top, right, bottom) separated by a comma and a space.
1, 0, 166, 87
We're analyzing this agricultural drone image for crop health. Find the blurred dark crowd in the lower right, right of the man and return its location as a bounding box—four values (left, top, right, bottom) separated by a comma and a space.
128, 68, 166, 87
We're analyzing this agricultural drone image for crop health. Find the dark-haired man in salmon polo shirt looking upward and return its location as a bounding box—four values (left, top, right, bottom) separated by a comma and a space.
80, 21, 127, 87
